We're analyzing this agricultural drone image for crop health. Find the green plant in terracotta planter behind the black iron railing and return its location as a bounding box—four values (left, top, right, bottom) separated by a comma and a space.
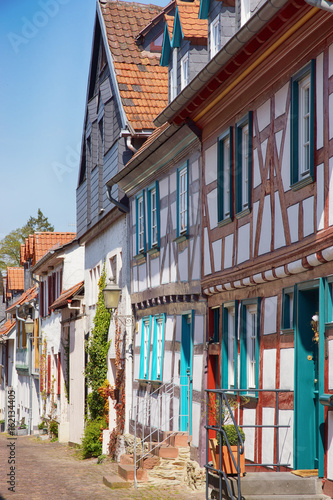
209, 424, 245, 477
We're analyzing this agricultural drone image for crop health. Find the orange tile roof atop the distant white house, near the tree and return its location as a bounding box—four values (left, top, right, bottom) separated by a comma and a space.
21, 232, 76, 266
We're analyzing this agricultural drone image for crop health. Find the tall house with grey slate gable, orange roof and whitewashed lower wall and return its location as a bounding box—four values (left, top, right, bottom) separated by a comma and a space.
77, 1, 168, 449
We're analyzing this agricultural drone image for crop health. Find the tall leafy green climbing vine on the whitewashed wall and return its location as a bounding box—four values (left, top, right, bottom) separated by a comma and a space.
85, 264, 110, 420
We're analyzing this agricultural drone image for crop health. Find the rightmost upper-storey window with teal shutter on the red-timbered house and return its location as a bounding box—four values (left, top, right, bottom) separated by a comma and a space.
291, 61, 315, 189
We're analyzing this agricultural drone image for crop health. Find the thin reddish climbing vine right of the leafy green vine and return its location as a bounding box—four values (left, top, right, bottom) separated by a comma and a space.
109, 316, 125, 459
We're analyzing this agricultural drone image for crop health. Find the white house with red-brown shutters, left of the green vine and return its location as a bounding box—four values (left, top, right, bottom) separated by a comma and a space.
30, 233, 85, 442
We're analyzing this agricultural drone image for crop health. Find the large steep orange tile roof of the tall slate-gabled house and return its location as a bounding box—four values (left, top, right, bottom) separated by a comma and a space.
100, 0, 168, 131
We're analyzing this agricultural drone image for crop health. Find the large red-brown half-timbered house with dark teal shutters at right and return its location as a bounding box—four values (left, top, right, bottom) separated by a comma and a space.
155, 0, 333, 491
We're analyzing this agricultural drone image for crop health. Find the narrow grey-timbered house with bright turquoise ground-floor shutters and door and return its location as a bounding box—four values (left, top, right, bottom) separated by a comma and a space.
111, 119, 206, 461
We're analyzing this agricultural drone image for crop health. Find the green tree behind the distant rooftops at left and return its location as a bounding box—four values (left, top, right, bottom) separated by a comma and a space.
0, 208, 54, 271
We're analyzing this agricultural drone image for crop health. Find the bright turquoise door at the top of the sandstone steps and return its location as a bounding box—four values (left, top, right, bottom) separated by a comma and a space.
179, 314, 192, 435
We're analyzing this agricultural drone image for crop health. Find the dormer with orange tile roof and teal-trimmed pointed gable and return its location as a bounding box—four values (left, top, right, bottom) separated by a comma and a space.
161, 0, 208, 102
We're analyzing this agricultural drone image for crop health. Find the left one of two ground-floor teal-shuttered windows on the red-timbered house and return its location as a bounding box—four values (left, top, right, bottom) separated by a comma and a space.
221, 302, 238, 389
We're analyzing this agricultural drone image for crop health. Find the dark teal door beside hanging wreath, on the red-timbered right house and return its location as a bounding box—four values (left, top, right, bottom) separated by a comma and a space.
294, 288, 319, 469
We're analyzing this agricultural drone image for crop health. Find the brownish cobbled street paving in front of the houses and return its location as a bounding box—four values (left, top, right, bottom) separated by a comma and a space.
0, 433, 205, 500
